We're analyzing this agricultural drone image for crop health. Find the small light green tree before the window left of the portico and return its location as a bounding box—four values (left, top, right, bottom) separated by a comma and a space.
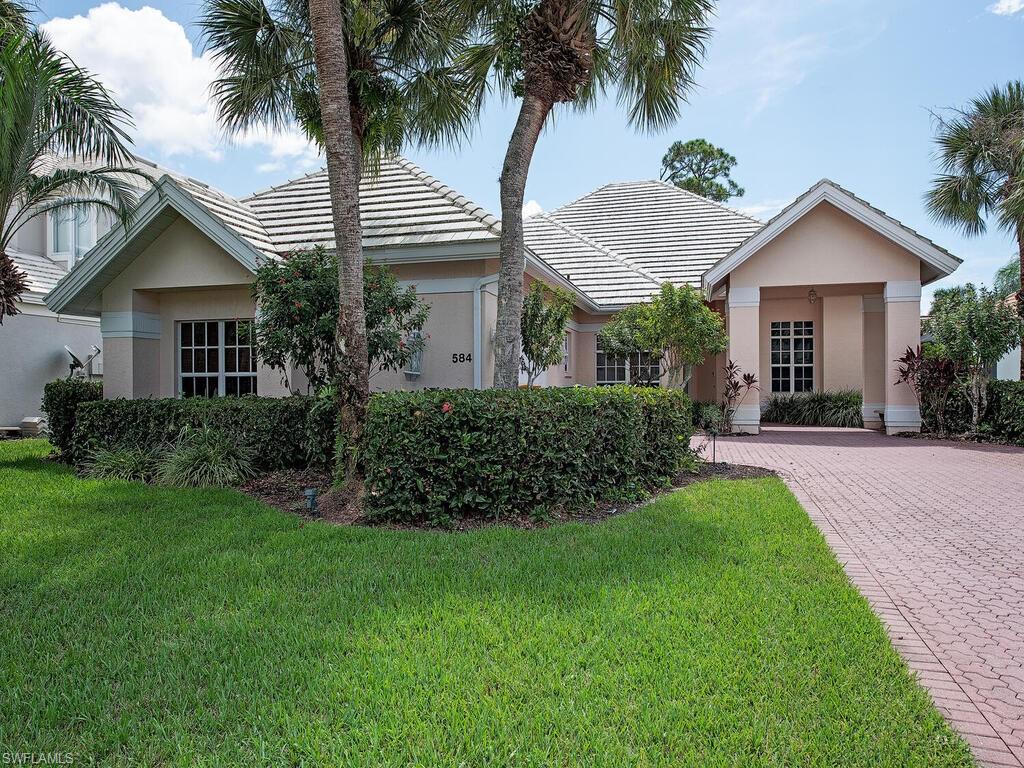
601, 283, 727, 386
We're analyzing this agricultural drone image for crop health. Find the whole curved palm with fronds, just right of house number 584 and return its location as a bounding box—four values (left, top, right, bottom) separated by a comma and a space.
462, 0, 714, 388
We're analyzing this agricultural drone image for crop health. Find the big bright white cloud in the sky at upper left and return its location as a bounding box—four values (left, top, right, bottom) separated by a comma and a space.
43, 2, 316, 169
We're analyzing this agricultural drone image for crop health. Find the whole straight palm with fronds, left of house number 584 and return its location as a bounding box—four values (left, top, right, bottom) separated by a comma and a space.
201, 0, 479, 477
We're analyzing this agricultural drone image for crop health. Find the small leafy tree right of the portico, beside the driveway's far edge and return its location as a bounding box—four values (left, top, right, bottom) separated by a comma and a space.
927, 284, 1022, 431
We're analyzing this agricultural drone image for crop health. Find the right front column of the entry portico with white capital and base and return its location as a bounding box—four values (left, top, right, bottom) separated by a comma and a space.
884, 281, 921, 434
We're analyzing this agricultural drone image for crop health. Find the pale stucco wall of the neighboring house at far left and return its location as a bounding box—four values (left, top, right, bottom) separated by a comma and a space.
0, 304, 102, 427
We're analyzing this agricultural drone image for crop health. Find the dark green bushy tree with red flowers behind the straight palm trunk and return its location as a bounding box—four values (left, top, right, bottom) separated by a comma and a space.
252, 247, 430, 390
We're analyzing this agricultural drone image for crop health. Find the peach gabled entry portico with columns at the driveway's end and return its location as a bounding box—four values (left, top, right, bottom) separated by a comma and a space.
702, 180, 959, 434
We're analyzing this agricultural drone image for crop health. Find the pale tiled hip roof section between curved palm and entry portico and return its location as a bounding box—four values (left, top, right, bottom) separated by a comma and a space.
526, 181, 764, 295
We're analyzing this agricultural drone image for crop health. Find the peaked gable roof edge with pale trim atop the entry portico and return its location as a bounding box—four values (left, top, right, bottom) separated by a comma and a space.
703, 178, 963, 290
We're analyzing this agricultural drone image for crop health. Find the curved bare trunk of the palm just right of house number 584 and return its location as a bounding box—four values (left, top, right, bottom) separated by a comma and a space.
495, 85, 552, 389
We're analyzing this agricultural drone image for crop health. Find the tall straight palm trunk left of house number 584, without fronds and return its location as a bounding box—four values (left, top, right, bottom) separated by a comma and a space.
309, 0, 370, 482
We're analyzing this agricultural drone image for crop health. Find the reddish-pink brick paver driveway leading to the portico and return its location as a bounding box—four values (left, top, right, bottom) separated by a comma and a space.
704, 427, 1024, 766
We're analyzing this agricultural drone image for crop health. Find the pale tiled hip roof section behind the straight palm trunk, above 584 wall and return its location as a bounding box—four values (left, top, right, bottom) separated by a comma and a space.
243, 158, 501, 253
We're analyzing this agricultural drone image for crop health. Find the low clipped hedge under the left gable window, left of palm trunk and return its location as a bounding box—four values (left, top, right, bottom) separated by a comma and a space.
71, 395, 336, 470
